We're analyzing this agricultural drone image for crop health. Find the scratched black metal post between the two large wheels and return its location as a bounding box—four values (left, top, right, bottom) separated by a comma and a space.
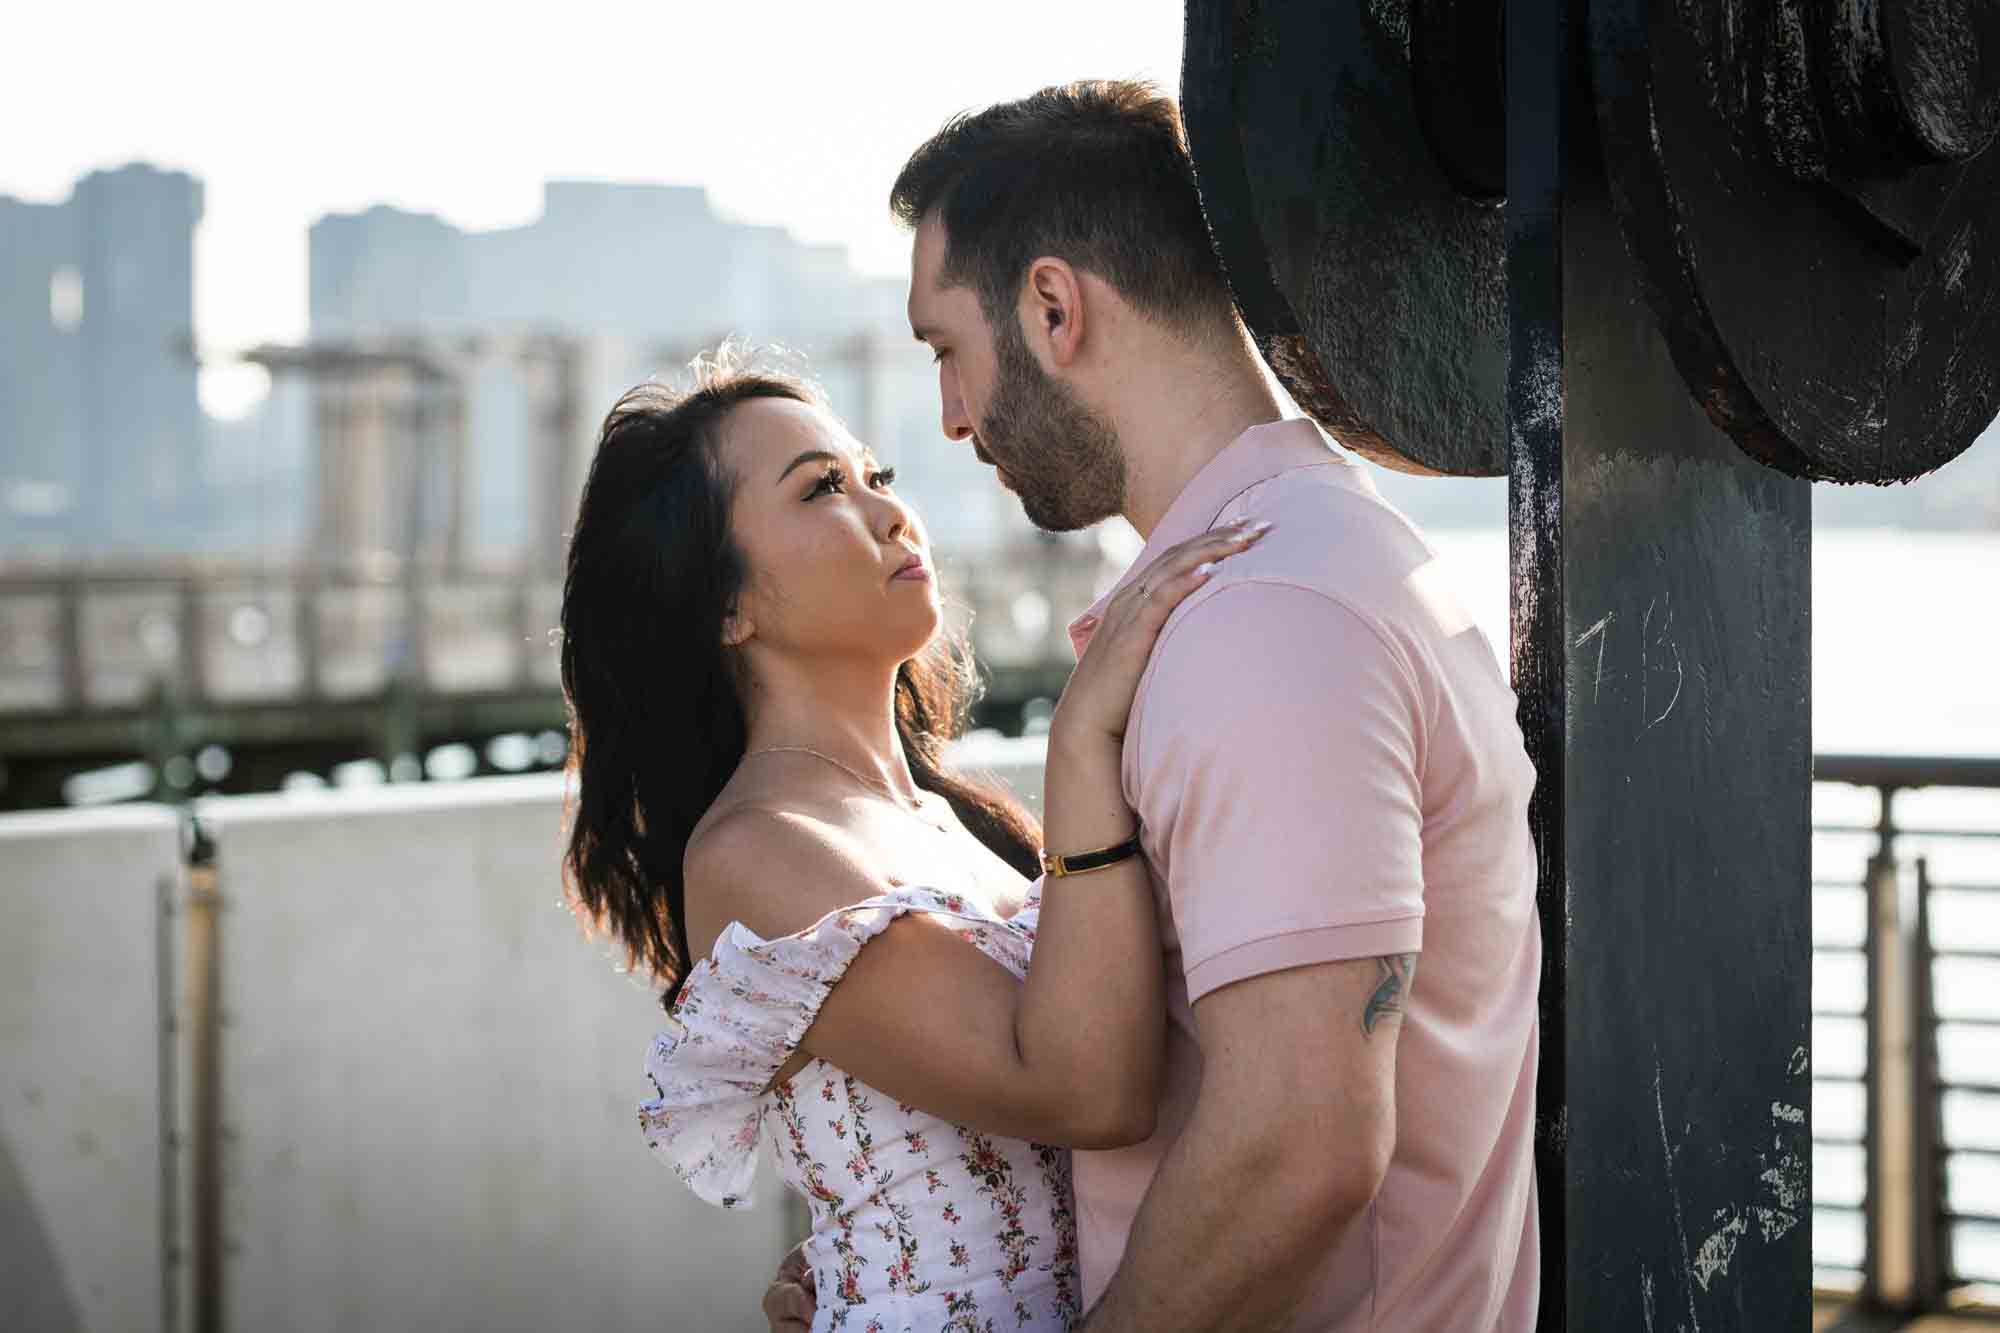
1508, 2, 1812, 1329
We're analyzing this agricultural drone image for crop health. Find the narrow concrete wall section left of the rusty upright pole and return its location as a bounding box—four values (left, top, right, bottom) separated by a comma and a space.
0, 807, 180, 1333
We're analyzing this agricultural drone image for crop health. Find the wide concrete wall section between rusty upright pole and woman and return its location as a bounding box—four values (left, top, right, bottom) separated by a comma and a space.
188, 777, 796, 1331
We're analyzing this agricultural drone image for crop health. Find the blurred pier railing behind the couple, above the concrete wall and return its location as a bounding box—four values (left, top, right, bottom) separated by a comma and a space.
0, 552, 1118, 811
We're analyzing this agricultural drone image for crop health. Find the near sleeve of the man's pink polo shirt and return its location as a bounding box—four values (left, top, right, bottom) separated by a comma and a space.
1132, 582, 1424, 1003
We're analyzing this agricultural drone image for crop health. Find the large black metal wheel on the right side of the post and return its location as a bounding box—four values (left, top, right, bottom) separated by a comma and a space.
1588, 0, 2000, 482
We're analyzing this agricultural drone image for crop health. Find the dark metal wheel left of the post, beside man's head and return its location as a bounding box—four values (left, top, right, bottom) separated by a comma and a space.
1182, 0, 1506, 476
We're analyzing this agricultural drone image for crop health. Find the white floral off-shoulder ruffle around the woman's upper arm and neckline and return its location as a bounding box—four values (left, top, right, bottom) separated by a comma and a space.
638, 889, 1038, 1209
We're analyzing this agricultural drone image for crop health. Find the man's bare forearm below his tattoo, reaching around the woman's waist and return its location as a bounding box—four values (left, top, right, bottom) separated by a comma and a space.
1080, 1107, 1368, 1333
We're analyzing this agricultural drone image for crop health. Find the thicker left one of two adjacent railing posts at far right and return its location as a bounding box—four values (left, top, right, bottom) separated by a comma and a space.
1860, 787, 1916, 1309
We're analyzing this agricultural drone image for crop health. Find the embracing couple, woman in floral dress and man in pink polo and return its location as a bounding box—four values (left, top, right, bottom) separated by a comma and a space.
562, 82, 1540, 1333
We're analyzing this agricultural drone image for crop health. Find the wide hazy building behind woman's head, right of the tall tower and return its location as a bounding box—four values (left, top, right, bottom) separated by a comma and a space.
296, 180, 1026, 566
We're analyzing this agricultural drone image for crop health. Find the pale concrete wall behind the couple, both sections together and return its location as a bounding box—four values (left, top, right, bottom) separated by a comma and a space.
0, 741, 1040, 1333
